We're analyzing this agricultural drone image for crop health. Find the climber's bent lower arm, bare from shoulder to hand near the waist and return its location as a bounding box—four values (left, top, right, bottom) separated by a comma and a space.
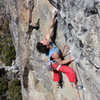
52, 53, 74, 65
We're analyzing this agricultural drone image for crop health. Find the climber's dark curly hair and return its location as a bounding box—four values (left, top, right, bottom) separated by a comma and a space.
36, 42, 49, 54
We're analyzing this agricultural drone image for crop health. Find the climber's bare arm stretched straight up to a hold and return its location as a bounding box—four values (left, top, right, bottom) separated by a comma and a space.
45, 11, 57, 41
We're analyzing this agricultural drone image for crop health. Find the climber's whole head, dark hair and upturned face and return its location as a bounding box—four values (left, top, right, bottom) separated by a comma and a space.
36, 41, 50, 54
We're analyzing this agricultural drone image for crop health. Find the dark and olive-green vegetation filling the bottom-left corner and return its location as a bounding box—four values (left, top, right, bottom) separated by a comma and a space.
0, 77, 22, 100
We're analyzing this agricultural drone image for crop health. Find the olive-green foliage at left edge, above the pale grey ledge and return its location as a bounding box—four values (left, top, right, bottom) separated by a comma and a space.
0, 34, 16, 66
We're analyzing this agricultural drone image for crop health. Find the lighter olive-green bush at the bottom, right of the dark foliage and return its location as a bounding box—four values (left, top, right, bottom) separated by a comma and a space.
8, 80, 22, 100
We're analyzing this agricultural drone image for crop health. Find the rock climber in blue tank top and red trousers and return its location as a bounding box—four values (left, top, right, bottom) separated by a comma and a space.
36, 10, 77, 87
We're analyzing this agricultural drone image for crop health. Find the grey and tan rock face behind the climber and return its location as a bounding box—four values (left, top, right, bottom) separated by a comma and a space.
4, 0, 100, 100
